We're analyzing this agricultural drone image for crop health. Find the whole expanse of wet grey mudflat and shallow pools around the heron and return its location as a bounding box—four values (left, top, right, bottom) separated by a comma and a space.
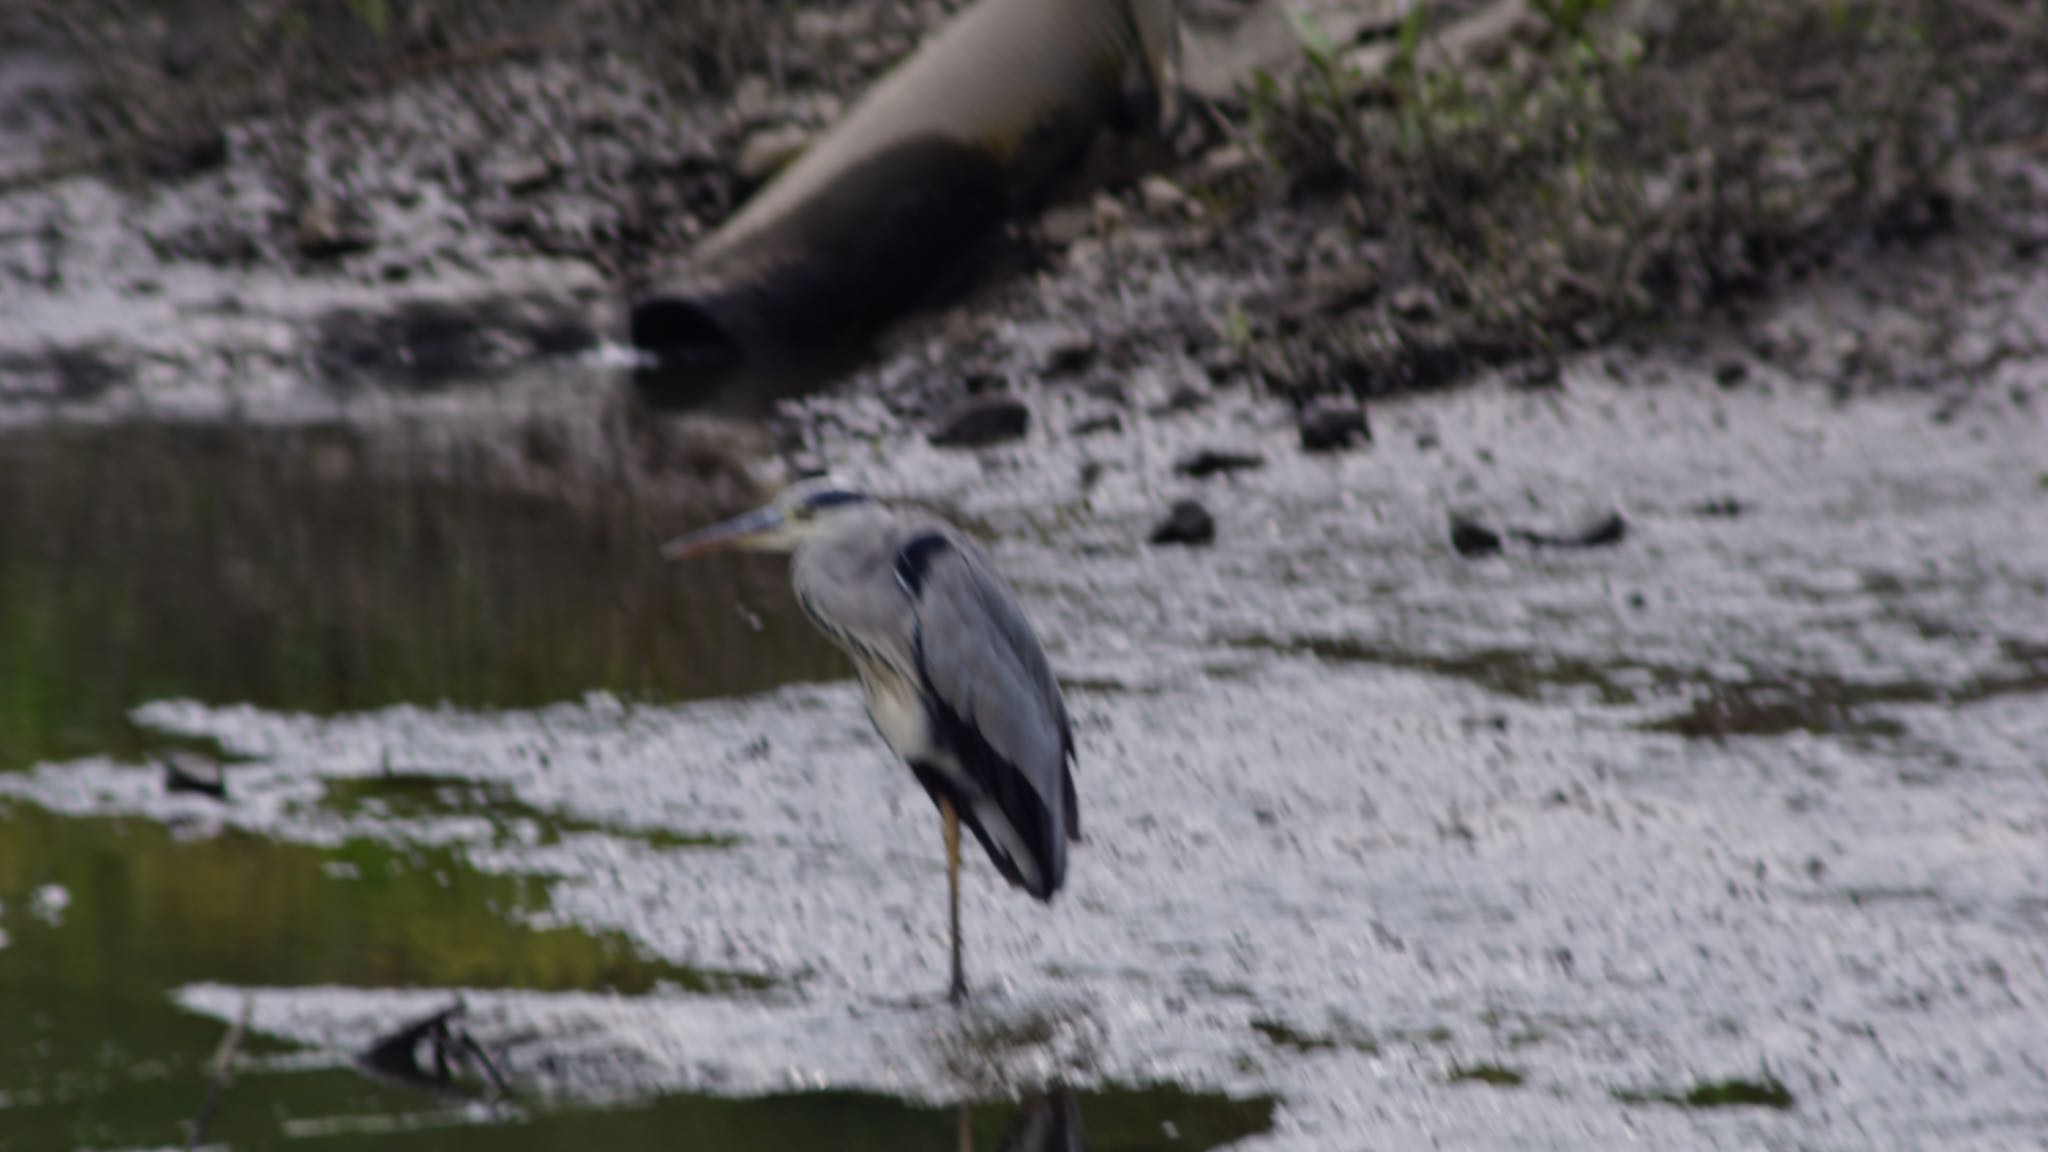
0, 369, 2048, 1150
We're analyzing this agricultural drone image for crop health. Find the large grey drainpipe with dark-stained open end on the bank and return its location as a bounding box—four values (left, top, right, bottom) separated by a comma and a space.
631, 0, 1171, 408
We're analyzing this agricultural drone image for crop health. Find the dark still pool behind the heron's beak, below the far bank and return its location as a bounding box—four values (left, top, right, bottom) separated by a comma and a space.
0, 424, 844, 771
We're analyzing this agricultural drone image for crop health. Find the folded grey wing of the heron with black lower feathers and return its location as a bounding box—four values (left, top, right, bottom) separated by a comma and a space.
897, 529, 1079, 900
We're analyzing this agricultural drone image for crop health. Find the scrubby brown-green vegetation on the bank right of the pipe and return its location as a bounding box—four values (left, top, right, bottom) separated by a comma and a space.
1247, 0, 2048, 387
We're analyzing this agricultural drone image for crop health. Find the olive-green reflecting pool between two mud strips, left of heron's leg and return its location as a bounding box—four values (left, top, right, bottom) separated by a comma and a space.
0, 806, 764, 1002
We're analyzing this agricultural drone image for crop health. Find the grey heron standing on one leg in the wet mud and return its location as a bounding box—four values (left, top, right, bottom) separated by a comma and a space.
662, 484, 1081, 1002
